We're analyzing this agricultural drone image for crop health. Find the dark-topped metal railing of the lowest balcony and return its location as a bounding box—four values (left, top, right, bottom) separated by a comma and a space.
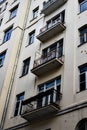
21, 88, 62, 114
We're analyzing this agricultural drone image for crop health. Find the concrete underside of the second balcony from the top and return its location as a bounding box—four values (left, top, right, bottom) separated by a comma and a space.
37, 23, 66, 42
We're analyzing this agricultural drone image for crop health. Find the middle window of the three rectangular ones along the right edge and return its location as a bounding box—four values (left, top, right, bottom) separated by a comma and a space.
80, 26, 87, 44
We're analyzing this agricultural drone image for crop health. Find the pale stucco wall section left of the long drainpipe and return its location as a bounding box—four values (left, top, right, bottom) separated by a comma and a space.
0, 0, 28, 125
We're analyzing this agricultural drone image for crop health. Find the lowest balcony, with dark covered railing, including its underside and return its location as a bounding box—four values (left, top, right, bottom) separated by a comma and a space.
21, 88, 62, 123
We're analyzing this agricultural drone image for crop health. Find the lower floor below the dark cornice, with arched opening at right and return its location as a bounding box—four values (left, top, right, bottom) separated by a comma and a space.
4, 104, 87, 130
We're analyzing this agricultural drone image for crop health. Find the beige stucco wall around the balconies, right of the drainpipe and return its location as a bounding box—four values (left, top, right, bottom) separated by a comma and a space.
1, 0, 87, 130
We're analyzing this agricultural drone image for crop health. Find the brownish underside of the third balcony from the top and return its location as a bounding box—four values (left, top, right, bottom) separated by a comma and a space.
31, 58, 63, 76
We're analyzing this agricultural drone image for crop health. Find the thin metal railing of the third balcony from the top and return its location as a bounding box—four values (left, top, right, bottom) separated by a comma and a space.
33, 48, 62, 68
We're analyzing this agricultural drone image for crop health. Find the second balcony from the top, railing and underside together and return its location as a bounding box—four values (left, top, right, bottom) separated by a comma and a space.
37, 18, 66, 42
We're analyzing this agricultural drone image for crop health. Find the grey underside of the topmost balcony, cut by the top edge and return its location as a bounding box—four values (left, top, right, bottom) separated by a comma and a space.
41, 0, 67, 16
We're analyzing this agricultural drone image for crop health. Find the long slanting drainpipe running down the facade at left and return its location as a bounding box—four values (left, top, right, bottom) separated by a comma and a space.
0, 0, 31, 130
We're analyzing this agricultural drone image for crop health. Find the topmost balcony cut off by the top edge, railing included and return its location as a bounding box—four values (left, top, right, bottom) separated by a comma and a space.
41, 0, 67, 16
